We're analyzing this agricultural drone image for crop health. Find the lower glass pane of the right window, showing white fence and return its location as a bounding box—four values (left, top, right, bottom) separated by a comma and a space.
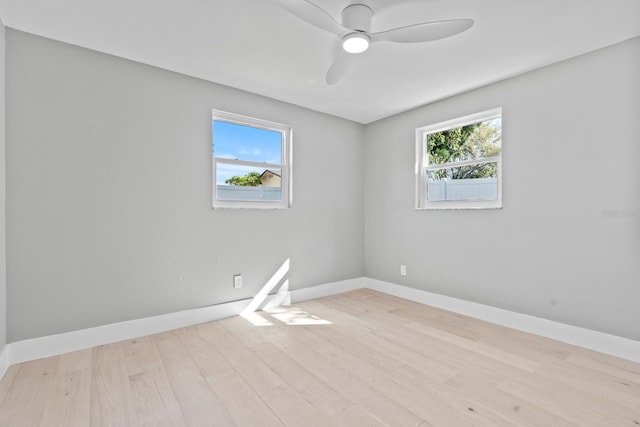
427, 162, 498, 202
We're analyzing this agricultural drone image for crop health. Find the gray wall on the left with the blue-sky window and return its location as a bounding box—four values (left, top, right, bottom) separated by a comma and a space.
6, 29, 364, 342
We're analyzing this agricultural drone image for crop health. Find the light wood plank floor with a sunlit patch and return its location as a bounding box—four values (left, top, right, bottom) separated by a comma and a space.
0, 290, 640, 427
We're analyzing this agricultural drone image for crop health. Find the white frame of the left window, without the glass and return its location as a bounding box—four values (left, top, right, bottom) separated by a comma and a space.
211, 109, 293, 209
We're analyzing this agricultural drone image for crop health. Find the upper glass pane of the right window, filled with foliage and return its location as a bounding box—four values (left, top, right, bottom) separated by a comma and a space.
425, 118, 502, 165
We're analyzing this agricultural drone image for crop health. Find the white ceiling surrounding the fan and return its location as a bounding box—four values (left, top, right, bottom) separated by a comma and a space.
0, 0, 640, 123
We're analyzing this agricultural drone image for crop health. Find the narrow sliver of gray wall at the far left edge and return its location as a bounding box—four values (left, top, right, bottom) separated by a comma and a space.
0, 19, 7, 351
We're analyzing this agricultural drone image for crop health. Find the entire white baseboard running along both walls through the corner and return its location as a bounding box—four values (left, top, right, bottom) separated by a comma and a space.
0, 277, 640, 384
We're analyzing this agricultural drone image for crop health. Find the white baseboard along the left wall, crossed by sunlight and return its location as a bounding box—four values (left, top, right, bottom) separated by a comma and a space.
5, 278, 365, 368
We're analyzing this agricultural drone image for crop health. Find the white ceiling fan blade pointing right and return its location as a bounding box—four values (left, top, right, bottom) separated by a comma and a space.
369, 19, 473, 43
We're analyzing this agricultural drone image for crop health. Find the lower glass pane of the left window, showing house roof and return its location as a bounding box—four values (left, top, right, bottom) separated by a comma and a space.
216, 161, 282, 201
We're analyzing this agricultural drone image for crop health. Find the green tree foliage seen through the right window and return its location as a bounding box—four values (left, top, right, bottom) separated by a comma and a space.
427, 121, 501, 179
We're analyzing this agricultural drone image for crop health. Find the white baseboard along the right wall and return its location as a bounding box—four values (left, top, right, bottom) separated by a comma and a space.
366, 278, 640, 362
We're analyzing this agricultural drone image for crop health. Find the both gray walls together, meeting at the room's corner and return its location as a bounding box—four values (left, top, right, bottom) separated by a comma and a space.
5, 30, 640, 342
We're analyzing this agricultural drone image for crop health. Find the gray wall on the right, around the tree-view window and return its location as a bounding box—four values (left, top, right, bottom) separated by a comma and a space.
364, 38, 640, 340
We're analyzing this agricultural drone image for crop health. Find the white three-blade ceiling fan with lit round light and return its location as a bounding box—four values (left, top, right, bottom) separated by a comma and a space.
277, 0, 473, 85
